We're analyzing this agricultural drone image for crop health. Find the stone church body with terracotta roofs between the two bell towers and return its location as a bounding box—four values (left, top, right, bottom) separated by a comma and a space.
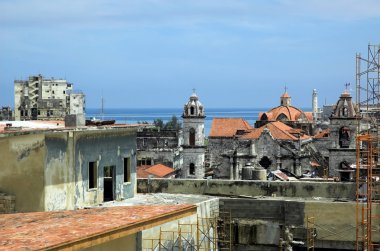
208, 118, 312, 180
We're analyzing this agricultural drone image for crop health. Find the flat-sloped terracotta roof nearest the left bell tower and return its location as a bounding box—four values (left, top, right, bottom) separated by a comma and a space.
209, 118, 253, 137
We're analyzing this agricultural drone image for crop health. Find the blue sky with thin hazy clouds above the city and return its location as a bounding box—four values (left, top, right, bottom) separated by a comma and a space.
0, 0, 380, 109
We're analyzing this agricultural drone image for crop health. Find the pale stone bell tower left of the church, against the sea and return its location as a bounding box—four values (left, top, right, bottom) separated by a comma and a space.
181, 90, 206, 179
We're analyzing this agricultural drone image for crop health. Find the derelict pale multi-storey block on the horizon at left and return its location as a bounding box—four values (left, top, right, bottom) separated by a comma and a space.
14, 75, 85, 120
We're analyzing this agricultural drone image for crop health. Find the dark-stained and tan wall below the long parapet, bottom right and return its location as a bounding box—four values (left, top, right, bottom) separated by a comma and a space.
220, 198, 380, 250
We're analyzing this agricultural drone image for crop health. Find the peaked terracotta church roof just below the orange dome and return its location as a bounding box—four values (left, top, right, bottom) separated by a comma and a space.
240, 121, 310, 140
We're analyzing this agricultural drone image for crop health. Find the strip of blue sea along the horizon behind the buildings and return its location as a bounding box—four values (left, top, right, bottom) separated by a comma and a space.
86, 108, 269, 136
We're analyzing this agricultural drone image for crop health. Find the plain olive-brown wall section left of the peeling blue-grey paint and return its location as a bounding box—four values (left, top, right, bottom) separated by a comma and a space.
0, 134, 46, 212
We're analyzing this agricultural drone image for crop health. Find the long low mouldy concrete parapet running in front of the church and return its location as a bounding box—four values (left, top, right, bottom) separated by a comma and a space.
137, 179, 356, 200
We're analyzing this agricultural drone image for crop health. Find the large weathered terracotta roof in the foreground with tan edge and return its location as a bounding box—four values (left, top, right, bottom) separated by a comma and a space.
0, 204, 196, 250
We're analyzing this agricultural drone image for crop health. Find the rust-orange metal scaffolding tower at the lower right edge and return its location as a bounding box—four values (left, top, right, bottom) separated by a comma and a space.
356, 134, 380, 251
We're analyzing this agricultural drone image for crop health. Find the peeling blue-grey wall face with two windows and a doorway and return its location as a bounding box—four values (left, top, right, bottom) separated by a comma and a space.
73, 130, 136, 207
